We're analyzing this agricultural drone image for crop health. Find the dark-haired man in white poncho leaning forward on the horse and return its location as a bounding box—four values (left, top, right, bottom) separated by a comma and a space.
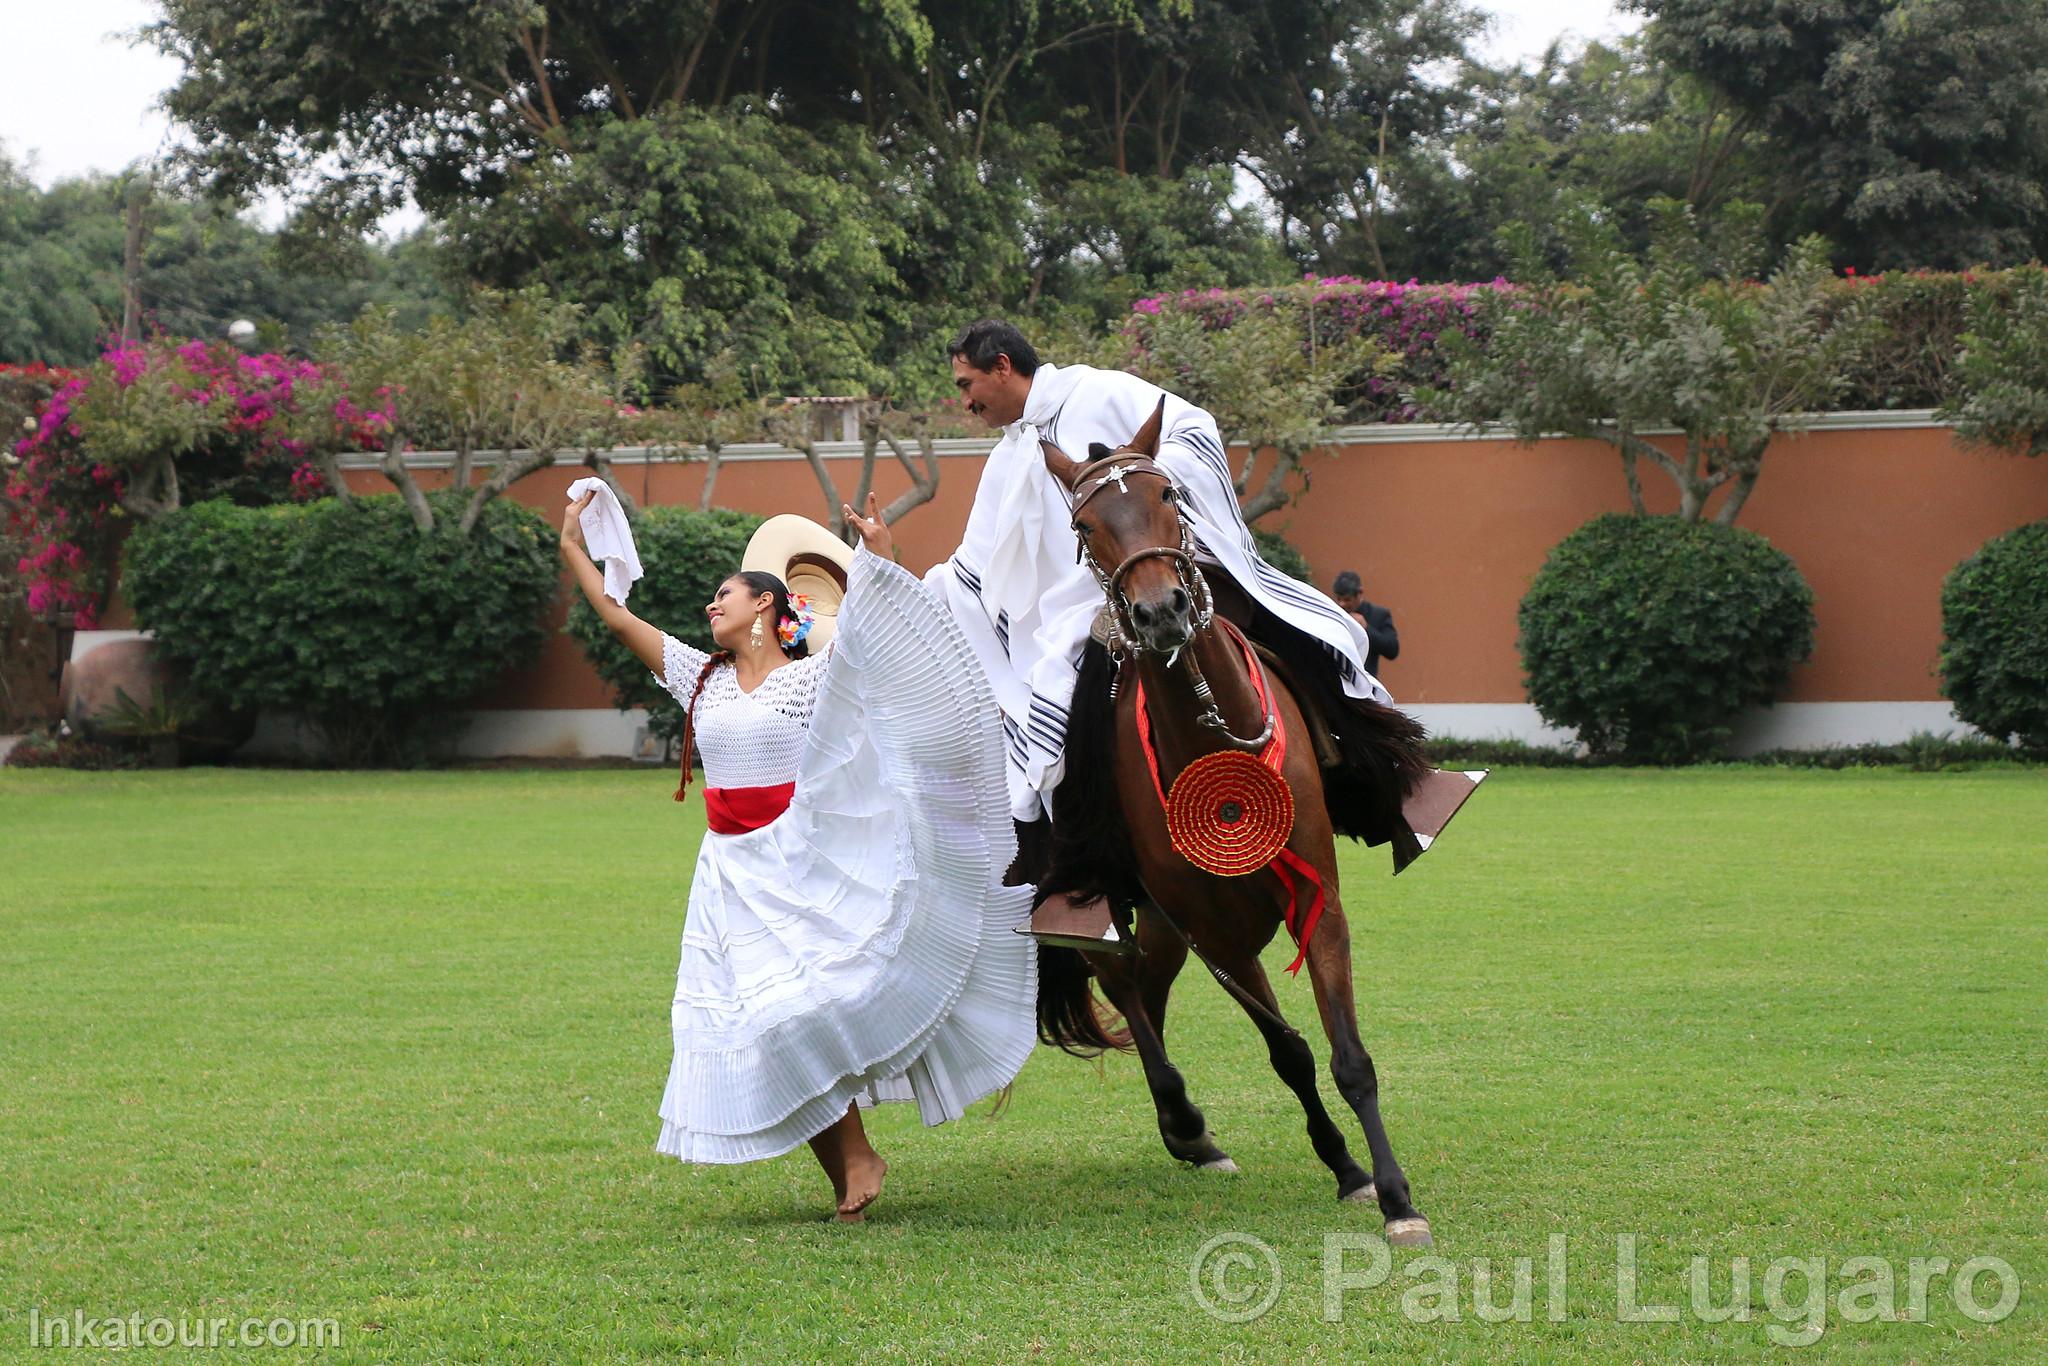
926, 319, 1427, 917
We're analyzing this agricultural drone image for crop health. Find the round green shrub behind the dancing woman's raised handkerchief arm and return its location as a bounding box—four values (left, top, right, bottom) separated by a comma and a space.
563, 508, 762, 741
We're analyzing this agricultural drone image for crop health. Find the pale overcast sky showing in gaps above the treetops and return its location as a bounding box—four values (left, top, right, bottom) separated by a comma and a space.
0, 0, 1638, 186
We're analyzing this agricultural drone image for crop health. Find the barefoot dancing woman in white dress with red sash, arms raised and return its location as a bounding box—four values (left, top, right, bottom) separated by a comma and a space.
561, 494, 1038, 1223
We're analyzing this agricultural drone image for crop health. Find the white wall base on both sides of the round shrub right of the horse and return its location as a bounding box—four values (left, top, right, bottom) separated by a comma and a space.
1403, 702, 1980, 756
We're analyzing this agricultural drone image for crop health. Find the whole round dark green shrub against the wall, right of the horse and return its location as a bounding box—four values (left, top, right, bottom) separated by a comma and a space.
1520, 514, 1812, 764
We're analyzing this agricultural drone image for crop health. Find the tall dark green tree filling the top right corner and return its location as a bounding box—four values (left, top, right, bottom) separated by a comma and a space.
1630, 0, 2048, 268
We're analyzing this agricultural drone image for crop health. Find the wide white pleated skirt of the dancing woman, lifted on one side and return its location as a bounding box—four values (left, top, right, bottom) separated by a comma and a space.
655, 551, 1038, 1163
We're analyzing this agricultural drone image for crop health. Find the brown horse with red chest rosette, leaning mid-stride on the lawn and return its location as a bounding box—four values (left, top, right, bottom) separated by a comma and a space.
1040, 397, 1430, 1247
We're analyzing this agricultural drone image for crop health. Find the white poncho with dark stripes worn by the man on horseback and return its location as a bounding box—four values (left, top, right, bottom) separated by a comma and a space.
926, 365, 1393, 821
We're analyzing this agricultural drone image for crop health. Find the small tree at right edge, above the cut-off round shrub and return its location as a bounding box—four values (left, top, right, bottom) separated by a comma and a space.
1942, 264, 2048, 455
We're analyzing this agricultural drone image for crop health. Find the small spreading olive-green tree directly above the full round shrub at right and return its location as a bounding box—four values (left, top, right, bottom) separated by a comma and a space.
1415, 201, 1872, 526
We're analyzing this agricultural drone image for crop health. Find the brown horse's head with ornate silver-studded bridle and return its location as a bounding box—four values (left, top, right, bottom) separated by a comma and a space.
1038, 397, 1212, 655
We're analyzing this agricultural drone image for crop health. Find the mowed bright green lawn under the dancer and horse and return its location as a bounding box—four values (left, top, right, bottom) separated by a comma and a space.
0, 770, 2048, 1362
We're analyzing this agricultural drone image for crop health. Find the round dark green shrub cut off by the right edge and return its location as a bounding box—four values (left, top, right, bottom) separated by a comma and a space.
1942, 522, 2048, 750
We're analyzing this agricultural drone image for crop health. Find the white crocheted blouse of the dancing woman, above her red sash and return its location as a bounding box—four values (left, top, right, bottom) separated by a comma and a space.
655, 631, 831, 786
